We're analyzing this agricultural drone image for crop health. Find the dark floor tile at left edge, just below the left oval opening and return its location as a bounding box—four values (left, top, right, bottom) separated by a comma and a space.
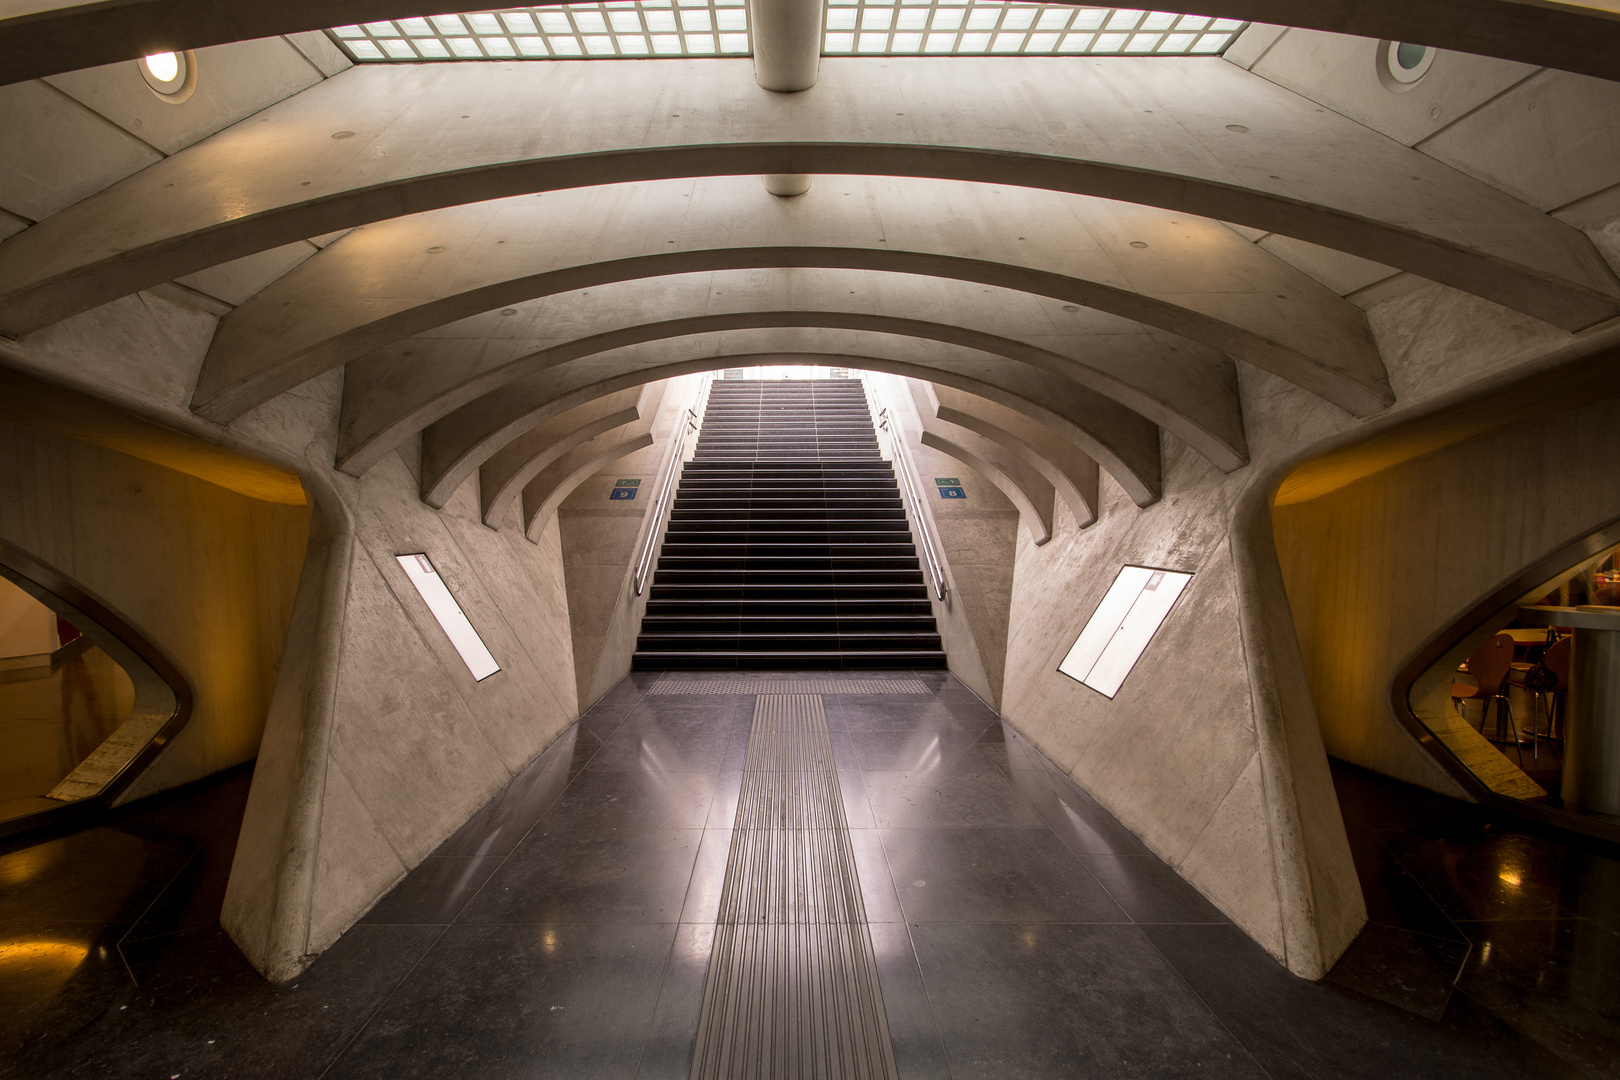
0, 826, 201, 923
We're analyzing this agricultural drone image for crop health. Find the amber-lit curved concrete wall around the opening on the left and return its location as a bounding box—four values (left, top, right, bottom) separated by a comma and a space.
0, 421, 308, 800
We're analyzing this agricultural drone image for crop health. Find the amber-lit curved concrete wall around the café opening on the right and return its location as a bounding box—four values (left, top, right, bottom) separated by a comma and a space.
1275, 400, 1620, 797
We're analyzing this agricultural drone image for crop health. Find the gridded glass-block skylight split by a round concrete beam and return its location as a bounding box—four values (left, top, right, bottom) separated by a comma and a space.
327, 0, 1247, 63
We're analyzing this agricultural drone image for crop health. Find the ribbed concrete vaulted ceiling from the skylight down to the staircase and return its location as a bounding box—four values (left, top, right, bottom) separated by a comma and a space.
0, 21, 1620, 541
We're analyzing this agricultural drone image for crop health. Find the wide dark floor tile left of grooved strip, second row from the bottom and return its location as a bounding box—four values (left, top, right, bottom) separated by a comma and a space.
458, 829, 705, 923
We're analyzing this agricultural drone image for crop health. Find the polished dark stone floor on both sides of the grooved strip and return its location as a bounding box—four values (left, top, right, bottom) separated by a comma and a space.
0, 672, 1620, 1080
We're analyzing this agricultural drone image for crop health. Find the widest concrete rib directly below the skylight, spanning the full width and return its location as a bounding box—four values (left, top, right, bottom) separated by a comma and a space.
0, 57, 1620, 335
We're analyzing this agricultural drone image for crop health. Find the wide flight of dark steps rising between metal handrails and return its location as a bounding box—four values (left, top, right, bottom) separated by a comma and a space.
633, 379, 946, 670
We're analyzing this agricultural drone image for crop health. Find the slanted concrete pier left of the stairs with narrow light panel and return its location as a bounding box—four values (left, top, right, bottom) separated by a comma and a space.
222, 433, 578, 980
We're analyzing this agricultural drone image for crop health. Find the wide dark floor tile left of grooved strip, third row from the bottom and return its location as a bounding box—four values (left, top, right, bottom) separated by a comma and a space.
541, 767, 719, 829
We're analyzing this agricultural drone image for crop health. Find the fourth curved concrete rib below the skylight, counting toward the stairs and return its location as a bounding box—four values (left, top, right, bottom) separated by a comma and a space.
411, 327, 1162, 505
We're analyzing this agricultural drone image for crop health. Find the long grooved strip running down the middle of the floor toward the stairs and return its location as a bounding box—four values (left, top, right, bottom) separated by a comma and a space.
692, 695, 897, 1080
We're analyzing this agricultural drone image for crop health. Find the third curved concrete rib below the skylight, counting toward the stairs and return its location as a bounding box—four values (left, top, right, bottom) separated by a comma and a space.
337, 275, 1247, 476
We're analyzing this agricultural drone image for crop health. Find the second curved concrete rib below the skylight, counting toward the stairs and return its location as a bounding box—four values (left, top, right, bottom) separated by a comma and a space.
193, 176, 1367, 437
